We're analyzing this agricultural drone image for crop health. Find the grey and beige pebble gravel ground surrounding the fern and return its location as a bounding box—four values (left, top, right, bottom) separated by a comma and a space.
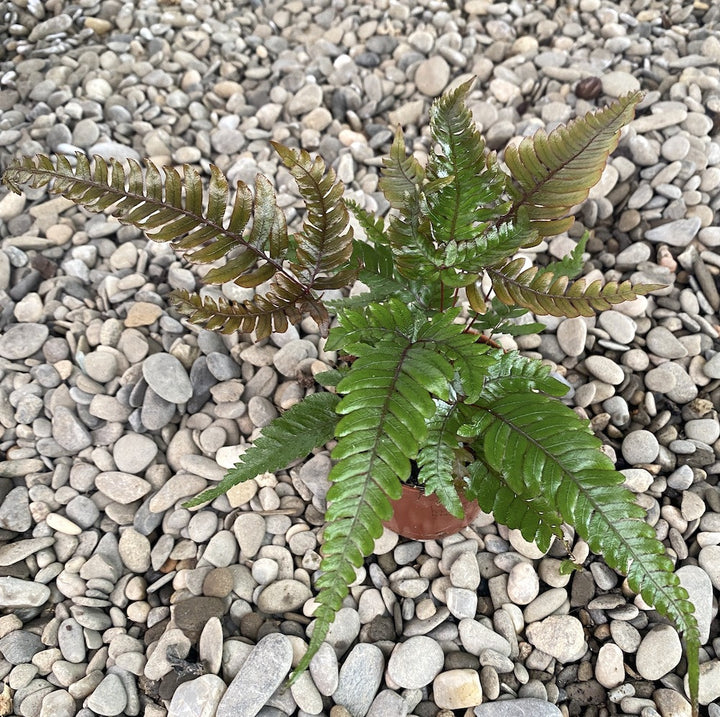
0, 0, 720, 717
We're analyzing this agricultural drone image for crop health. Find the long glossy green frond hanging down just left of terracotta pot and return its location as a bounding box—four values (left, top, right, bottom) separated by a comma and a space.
290, 328, 452, 682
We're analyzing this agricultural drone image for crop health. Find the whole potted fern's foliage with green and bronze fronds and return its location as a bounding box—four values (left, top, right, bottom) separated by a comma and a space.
3, 83, 699, 714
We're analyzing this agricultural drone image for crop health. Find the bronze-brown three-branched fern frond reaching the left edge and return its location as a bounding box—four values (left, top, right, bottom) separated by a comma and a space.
3, 150, 344, 339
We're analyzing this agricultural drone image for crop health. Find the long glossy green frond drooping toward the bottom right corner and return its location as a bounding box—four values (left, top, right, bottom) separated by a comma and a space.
461, 392, 699, 694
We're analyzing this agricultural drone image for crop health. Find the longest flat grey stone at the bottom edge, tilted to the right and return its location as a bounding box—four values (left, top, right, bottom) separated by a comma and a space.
216, 633, 292, 717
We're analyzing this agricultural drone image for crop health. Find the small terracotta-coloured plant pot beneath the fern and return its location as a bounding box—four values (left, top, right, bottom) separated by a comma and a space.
383, 484, 480, 540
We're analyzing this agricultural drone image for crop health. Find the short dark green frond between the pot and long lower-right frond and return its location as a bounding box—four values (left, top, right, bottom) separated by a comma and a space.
465, 456, 563, 551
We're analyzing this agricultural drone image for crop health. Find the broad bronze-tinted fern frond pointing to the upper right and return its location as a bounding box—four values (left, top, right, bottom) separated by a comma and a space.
504, 92, 642, 237
